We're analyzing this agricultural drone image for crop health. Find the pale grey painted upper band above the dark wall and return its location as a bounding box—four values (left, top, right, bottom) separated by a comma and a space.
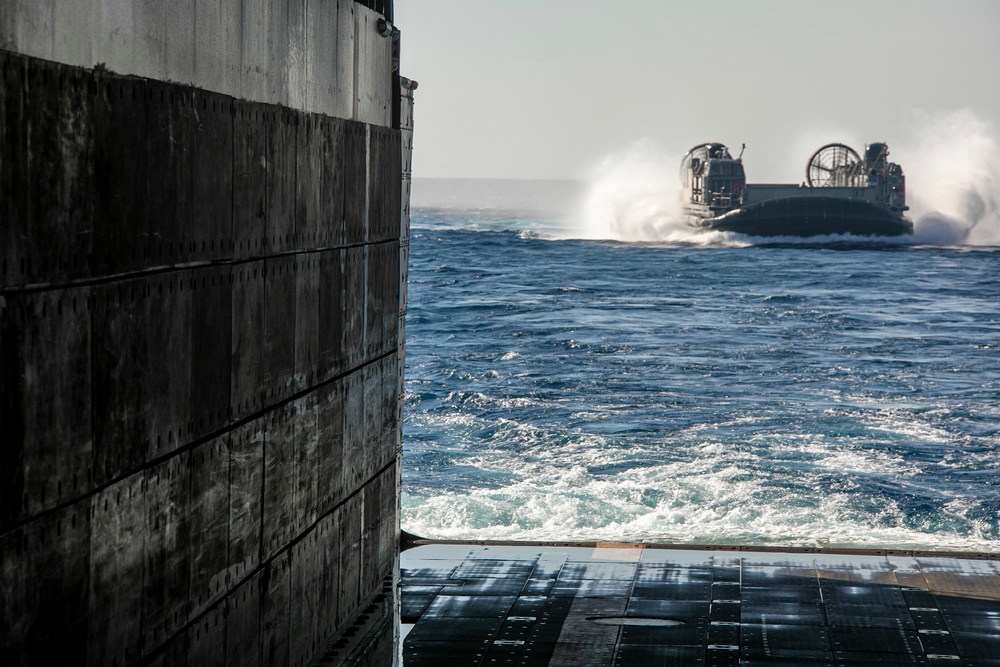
0, 0, 394, 126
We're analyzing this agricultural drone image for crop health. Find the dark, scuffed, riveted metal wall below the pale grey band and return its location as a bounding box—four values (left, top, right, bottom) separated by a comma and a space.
0, 18, 412, 666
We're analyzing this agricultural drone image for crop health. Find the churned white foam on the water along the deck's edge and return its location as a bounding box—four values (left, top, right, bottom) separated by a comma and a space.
403, 425, 1000, 551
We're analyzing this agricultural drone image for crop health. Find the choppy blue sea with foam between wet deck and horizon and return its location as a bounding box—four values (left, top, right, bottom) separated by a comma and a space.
402, 179, 1000, 552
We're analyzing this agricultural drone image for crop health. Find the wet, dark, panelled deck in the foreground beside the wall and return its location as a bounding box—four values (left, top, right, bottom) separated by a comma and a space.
401, 544, 1000, 667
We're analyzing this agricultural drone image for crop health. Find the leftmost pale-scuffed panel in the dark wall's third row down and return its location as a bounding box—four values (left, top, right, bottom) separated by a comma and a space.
87, 473, 146, 665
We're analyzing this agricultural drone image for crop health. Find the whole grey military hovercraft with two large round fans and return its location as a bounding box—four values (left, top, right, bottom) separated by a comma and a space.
681, 143, 913, 236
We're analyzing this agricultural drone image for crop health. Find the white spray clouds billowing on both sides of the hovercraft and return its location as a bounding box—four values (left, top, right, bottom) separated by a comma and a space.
566, 111, 1000, 246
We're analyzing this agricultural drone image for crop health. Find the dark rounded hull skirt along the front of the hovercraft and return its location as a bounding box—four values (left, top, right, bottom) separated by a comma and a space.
694, 197, 913, 236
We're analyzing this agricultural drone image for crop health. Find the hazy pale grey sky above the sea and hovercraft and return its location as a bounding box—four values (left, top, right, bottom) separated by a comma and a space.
395, 0, 1000, 181
